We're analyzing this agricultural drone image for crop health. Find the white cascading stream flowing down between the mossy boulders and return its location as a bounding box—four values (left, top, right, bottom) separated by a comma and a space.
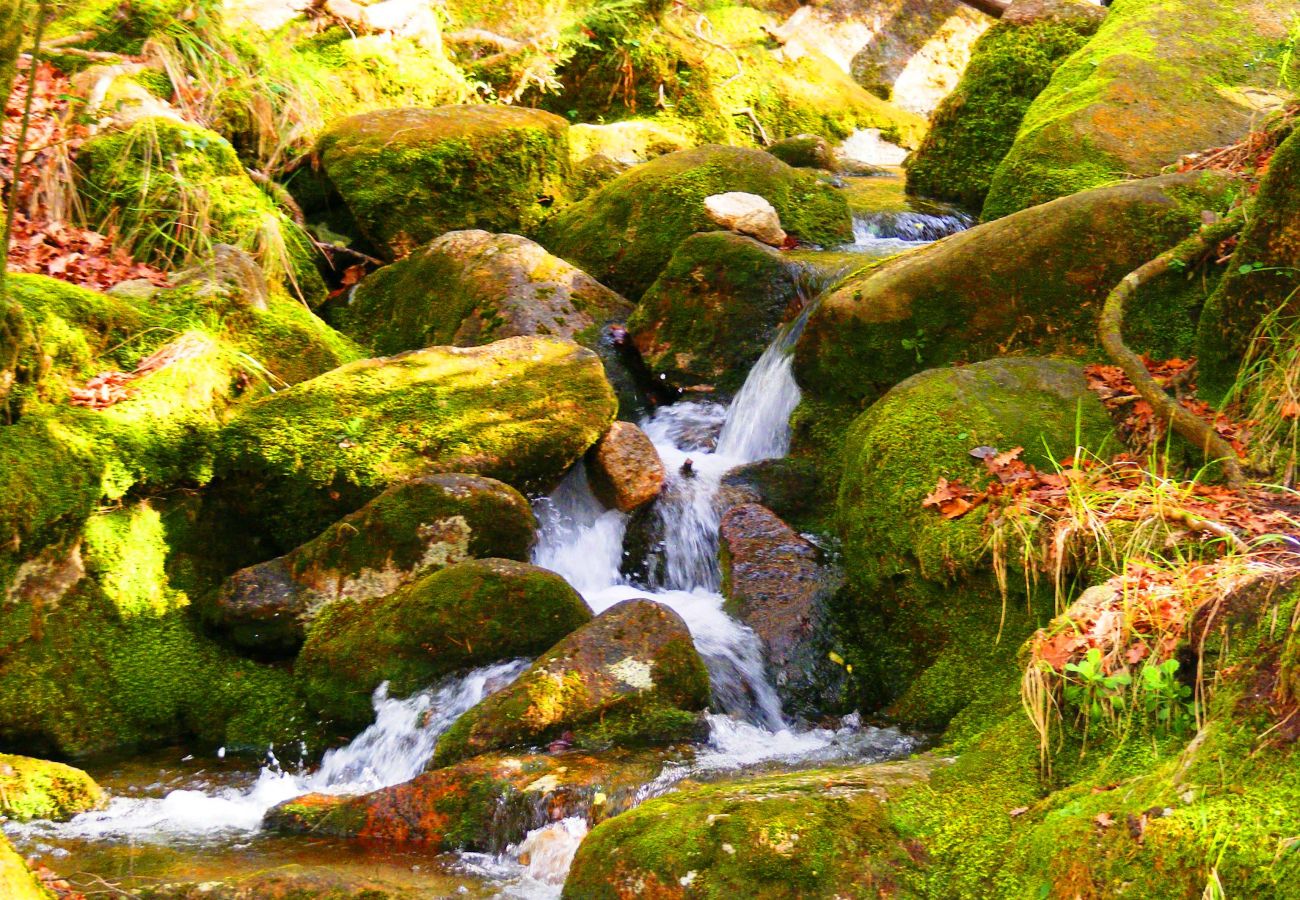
5, 158, 970, 900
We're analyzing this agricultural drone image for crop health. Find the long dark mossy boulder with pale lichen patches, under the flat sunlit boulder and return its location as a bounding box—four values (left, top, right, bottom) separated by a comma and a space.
208, 475, 536, 652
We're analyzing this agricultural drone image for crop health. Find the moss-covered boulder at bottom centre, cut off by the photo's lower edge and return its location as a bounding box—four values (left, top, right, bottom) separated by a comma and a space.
564, 758, 941, 900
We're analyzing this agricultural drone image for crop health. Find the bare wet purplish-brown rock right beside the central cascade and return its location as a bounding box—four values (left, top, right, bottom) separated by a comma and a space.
719, 503, 845, 718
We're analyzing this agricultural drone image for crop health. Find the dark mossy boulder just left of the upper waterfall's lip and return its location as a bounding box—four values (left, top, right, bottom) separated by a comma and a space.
628, 232, 802, 393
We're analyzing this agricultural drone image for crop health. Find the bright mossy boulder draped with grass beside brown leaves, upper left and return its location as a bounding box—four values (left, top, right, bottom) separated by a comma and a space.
77, 117, 326, 304
